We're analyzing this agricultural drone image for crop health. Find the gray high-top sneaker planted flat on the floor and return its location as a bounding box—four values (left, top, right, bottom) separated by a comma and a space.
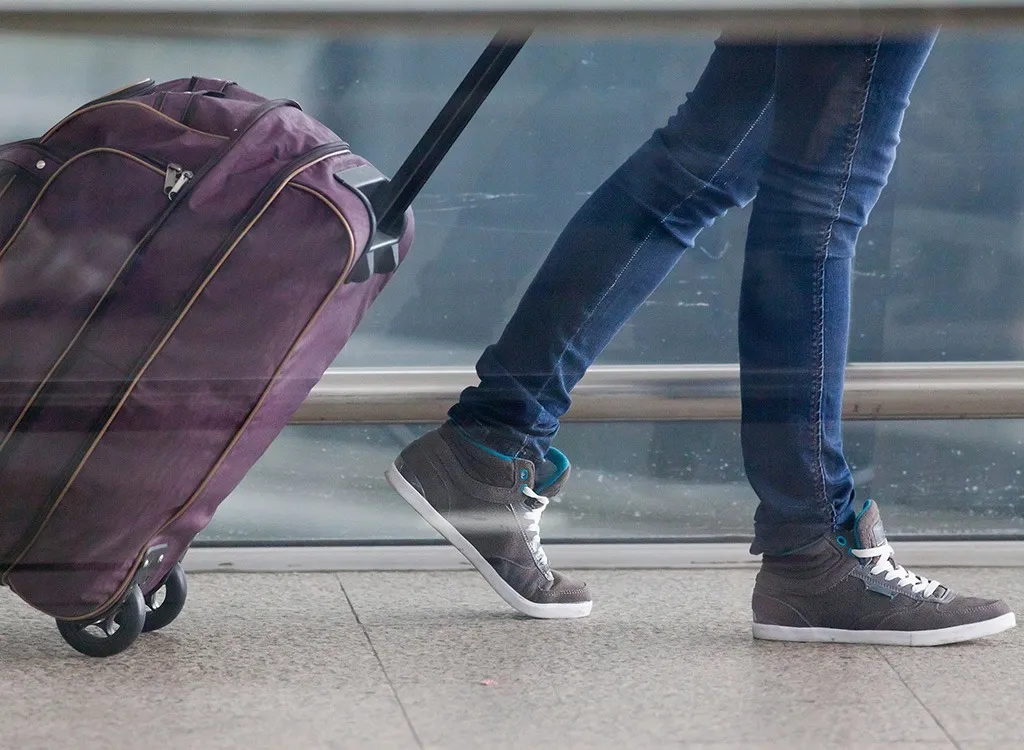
753, 500, 1017, 645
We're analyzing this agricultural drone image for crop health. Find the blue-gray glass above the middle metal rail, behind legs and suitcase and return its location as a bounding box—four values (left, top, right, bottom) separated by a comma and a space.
0, 30, 1024, 366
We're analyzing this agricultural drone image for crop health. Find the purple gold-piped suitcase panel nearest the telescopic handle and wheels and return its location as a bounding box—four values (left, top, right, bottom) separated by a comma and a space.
8, 178, 354, 619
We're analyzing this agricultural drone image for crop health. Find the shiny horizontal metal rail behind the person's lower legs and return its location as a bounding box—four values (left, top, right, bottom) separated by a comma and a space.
293, 362, 1024, 424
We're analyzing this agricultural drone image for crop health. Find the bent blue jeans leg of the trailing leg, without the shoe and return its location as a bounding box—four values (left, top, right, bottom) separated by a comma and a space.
450, 42, 775, 460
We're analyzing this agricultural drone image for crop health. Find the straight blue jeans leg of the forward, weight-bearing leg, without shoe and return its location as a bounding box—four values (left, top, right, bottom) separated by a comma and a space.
739, 36, 934, 553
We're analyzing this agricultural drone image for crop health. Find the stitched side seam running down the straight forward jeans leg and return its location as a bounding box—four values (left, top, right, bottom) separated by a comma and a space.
812, 37, 882, 531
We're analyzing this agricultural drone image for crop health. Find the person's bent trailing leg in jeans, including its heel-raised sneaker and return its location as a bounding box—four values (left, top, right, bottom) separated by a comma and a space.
387, 38, 775, 618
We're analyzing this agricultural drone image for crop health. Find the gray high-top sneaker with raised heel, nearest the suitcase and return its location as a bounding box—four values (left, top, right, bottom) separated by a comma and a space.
386, 423, 592, 619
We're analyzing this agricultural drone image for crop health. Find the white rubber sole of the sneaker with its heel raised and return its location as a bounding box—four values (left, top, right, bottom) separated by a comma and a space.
384, 463, 594, 620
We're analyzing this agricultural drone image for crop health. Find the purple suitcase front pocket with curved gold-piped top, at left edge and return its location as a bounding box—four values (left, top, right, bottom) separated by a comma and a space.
0, 149, 168, 456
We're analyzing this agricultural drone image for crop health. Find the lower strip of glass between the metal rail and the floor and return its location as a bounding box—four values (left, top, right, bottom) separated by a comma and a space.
200, 420, 1024, 543
